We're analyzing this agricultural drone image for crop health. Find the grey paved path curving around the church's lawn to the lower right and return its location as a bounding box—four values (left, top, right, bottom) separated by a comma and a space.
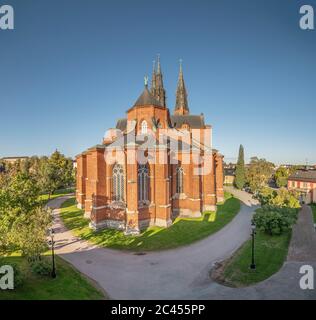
49, 190, 316, 299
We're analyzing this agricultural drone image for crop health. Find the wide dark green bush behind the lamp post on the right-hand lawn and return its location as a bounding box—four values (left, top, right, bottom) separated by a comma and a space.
253, 206, 297, 235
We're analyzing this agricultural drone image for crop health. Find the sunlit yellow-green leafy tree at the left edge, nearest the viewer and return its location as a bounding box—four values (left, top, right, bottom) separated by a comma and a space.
0, 170, 51, 259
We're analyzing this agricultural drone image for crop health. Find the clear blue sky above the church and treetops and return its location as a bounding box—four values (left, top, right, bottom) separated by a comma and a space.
0, 0, 316, 163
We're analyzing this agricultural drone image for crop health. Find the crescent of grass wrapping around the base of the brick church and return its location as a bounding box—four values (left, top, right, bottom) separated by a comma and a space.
61, 194, 240, 251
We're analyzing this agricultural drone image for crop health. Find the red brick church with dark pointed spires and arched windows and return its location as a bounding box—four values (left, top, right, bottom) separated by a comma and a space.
76, 58, 224, 234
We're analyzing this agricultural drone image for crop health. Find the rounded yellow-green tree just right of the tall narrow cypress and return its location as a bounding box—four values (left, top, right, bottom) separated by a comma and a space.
246, 157, 274, 192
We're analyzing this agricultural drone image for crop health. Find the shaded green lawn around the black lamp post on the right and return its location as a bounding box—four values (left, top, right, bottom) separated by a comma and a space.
223, 231, 291, 287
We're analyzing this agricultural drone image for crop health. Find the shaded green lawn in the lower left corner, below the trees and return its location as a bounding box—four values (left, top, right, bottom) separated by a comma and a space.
0, 255, 105, 300
